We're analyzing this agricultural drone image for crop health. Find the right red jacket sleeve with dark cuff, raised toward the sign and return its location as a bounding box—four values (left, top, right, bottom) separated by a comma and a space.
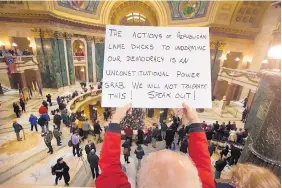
188, 124, 215, 188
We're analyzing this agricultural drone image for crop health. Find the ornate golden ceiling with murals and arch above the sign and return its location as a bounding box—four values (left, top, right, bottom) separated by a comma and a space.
0, 0, 278, 38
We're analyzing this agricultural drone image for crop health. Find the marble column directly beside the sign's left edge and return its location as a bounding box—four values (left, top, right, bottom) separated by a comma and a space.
95, 37, 105, 81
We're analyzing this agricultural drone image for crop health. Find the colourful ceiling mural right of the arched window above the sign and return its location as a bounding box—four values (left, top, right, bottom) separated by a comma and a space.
168, 1, 209, 20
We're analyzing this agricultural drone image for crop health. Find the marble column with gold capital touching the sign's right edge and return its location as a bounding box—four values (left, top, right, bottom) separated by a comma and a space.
210, 41, 225, 93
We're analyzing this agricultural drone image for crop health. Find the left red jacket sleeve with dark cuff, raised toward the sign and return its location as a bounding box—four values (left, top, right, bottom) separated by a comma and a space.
95, 124, 131, 188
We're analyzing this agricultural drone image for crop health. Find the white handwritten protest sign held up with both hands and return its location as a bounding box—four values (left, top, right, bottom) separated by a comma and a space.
102, 25, 212, 108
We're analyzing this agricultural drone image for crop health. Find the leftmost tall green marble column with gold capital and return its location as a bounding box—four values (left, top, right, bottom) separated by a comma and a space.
31, 28, 51, 88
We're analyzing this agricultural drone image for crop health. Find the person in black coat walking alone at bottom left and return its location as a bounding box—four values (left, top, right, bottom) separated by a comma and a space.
54, 157, 70, 186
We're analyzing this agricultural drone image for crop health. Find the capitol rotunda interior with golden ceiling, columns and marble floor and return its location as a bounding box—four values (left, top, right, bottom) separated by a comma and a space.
0, 0, 282, 188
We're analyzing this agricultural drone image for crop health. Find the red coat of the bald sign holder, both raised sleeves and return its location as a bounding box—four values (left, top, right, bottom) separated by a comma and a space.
95, 124, 215, 188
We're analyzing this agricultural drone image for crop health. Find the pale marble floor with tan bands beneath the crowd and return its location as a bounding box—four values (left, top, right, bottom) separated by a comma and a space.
0, 85, 244, 187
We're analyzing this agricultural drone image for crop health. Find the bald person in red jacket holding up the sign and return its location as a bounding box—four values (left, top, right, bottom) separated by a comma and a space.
95, 104, 215, 188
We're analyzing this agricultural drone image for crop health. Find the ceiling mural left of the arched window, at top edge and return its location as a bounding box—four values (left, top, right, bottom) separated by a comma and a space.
58, 0, 99, 14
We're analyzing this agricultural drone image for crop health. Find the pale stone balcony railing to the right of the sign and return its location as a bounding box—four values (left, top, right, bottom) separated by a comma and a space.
218, 67, 260, 87
